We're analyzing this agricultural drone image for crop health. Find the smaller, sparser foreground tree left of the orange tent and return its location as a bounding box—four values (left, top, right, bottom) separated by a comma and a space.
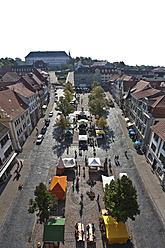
28, 183, 58, 224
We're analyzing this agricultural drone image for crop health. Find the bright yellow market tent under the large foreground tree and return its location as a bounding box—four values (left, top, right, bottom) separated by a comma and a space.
102, 215, 129, 244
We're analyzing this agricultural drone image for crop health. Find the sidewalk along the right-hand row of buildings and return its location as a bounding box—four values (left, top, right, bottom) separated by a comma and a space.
118, 115, 165, 226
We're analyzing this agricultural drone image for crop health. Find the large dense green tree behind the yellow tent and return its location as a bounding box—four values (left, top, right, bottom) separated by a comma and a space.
104, 176, 140, 222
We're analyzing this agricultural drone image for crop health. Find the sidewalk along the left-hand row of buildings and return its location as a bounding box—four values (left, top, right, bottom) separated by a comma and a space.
0, 89, 54, 227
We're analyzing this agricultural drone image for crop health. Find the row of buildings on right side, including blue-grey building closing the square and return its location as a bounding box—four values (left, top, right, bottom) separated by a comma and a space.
74, 61, 165, 184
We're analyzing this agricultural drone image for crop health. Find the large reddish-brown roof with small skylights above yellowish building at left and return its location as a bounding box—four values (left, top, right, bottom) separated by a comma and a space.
0, 89, 29, 120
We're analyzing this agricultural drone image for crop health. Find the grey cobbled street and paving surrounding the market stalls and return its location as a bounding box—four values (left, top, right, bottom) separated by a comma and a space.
0, 80, 165, 248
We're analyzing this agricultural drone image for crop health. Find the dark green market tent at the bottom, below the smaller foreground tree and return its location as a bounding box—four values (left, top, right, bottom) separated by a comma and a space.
43, 218, 65, 242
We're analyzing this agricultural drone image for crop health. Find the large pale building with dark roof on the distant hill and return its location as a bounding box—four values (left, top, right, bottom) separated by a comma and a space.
25, 51, 70, 67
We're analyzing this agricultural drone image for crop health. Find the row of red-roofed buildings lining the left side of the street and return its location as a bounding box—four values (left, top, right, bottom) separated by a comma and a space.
0, 68, 50, 182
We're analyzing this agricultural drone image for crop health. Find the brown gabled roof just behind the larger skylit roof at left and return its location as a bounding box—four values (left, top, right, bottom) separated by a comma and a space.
7, 83, 35, 98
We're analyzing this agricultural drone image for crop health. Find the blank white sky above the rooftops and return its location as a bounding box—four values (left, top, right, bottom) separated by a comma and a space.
0, 0, 165, 66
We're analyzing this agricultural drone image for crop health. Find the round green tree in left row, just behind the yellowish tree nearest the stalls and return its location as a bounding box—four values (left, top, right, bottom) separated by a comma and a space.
55, 96, 74, 117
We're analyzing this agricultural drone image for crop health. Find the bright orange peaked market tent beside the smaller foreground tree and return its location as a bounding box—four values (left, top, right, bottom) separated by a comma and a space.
50, 176, 67, 200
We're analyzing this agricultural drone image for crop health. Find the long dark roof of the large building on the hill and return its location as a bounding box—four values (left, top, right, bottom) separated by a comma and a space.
25, 51, 69, 58
